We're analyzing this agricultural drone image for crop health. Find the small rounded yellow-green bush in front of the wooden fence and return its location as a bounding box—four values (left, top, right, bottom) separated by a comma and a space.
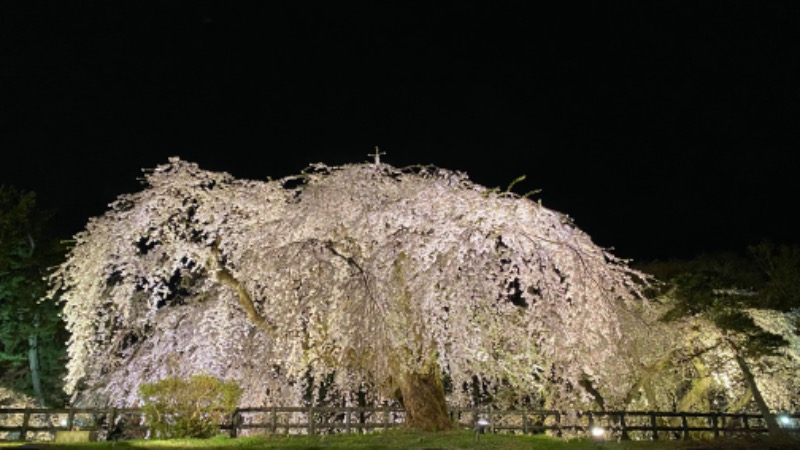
139, 375, 242, 439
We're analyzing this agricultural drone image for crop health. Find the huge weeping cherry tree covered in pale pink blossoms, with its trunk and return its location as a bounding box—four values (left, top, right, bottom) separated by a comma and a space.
52, 158, 640, 429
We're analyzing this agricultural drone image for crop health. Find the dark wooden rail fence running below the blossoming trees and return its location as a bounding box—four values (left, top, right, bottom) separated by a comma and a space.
0, 407, 800, 441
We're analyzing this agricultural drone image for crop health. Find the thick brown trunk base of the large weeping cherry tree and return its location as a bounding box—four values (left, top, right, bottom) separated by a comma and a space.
400, 370, 453, 431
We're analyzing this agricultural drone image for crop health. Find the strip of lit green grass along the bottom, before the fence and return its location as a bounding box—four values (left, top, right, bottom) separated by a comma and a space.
0, 430, 800, 450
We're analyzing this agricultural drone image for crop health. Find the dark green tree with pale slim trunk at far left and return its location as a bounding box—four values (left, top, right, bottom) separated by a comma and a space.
0, 186, 67, 405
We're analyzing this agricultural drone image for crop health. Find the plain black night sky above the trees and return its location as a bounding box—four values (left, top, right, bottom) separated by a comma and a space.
0, 0, 800, 261
